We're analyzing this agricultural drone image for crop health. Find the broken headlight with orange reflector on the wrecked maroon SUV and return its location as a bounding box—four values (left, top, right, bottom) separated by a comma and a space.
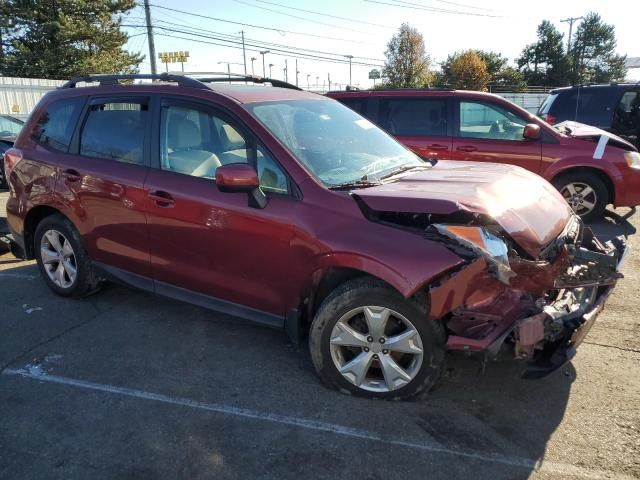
434, 224, 513, 284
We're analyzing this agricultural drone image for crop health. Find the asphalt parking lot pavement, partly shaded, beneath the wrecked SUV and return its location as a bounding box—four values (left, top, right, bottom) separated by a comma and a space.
0, 188, 640, 479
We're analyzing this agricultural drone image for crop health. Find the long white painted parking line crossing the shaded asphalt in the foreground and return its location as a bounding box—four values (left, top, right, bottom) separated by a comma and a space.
2, 365, 632, 480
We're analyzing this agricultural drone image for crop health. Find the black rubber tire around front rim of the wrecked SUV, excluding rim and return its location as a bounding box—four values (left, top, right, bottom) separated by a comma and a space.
309, 278, 445, 400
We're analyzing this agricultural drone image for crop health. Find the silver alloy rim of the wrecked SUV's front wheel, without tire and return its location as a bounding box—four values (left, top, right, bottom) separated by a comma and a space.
330, 306, 424, 392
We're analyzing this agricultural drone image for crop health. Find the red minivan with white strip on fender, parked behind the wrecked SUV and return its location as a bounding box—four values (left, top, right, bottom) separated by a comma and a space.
328, 90, 640, 220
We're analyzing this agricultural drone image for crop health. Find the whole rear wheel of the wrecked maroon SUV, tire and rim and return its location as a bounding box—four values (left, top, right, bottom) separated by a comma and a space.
34, 215, 98, 297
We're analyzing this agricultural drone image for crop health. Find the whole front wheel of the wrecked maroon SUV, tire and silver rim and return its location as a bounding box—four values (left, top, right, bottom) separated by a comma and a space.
309, 278, 444, 399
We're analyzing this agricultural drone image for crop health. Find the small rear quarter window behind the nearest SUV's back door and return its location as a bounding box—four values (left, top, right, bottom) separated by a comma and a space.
32, 97, 85, 152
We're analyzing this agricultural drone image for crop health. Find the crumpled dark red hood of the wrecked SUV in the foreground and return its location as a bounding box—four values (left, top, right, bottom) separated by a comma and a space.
353, 160, 573, 257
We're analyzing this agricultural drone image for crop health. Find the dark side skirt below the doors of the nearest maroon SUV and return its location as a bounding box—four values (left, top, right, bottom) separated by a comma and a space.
93, 262, 285, 329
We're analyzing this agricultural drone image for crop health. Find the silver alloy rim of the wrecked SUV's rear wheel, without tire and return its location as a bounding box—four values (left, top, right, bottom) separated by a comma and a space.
40, 230, 78, 288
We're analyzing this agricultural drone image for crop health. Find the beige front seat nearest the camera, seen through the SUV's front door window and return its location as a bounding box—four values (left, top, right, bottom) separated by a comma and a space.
167, 116, 221, 178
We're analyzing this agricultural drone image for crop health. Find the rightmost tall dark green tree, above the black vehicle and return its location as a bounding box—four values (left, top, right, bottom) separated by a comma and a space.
569, 12, 627, 83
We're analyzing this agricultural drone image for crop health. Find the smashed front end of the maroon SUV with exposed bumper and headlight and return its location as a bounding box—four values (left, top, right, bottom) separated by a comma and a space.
429, 216, 626, 378
